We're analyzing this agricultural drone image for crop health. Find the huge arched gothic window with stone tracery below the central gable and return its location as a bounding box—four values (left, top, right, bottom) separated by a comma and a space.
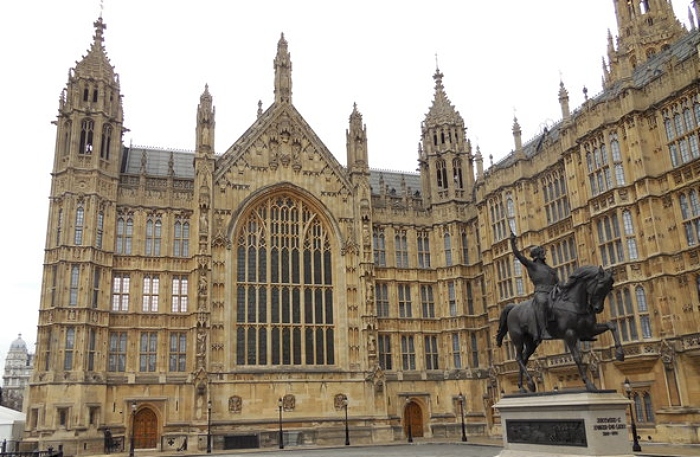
234, 194, 335, 365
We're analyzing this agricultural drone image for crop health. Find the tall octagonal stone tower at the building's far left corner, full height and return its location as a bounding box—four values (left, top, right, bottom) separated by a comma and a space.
30, 17, 123, 439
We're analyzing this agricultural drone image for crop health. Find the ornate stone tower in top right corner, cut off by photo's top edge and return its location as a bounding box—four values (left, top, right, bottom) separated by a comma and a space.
603, 0, 686, 89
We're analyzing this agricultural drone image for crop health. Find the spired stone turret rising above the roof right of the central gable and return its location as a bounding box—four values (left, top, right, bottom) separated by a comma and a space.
418, 68, 474, 205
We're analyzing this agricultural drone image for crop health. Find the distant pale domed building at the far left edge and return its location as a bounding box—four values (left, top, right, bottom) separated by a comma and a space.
2, 334, 34, 411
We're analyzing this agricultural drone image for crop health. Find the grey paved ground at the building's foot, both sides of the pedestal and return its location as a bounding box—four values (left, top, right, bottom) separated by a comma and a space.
104, 437, 700, 457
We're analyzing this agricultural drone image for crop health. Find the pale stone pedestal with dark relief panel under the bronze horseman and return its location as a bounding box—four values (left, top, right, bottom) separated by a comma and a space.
494, 391, 633, 457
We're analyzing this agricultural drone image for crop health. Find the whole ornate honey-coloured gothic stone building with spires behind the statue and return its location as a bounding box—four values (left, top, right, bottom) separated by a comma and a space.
23, 0, 700, 455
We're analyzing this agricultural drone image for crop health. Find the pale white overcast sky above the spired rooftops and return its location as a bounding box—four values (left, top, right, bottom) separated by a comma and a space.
0, 0, 690, 364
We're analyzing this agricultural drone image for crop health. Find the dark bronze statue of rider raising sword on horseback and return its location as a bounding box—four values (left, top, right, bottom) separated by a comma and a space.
496, 232, 625, 392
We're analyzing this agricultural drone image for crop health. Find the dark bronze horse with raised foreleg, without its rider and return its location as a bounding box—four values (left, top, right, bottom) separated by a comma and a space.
496, 265, 625, 392
